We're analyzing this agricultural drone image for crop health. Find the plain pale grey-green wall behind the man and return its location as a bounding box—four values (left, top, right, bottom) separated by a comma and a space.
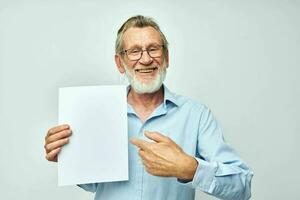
0, 0, 300, 200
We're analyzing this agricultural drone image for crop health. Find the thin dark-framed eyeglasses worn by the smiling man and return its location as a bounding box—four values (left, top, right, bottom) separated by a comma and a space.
120, 45, 164, 61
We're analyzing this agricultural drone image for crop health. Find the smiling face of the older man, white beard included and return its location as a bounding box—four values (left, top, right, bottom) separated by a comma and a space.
119, 27, 168, 93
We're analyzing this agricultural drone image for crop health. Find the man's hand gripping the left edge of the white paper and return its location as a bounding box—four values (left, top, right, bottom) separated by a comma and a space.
44, 124, 72, 162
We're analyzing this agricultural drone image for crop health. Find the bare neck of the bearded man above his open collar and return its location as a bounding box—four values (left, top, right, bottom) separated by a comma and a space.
127, 87, 164, 110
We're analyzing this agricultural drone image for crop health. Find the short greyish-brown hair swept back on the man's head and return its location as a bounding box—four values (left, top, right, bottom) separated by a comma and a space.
115, 15, 169, 56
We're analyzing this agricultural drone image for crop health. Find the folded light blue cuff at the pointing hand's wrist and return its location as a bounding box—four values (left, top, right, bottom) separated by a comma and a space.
178, 157, 218, 193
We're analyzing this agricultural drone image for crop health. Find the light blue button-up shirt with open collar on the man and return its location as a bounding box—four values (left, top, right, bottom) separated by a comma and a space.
79, 86, 253, 200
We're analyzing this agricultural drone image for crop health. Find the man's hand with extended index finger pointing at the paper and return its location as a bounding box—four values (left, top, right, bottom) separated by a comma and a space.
131, 131, 198, 180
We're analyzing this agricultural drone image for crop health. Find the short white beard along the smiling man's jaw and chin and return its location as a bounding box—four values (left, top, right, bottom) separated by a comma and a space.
122, 61, 167, 94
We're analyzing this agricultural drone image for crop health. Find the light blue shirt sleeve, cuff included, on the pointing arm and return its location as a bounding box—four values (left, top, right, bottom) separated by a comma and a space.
179, 106, 253, 200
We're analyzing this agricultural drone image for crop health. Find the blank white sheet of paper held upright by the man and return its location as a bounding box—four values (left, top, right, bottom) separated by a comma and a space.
58, 85, 128, 186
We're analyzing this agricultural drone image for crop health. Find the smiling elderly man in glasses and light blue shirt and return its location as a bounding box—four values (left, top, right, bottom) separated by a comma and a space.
45, 16, 253, 200
